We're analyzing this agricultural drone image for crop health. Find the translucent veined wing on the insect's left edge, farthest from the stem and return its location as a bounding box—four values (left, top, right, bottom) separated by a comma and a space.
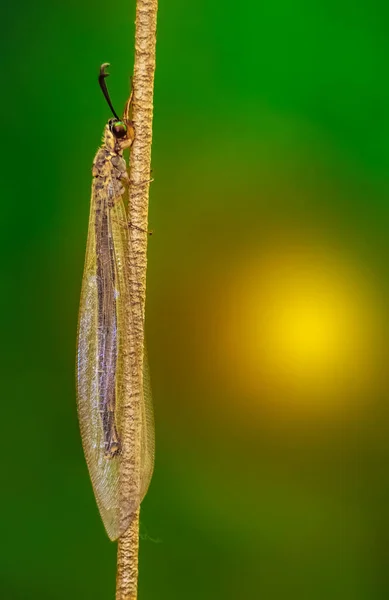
77, 180, 123, 539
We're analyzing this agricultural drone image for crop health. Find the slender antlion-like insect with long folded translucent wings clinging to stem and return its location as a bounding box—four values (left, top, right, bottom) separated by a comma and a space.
76, 63, 154, 540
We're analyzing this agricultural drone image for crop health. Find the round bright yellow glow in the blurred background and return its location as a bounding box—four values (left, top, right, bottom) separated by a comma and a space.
220, 247, 379, 406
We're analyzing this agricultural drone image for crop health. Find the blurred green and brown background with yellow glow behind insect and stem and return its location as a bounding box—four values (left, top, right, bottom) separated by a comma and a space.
0, 0, 389, 600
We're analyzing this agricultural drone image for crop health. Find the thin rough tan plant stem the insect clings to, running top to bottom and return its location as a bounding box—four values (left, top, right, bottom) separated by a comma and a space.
116, 0, 158, 600
